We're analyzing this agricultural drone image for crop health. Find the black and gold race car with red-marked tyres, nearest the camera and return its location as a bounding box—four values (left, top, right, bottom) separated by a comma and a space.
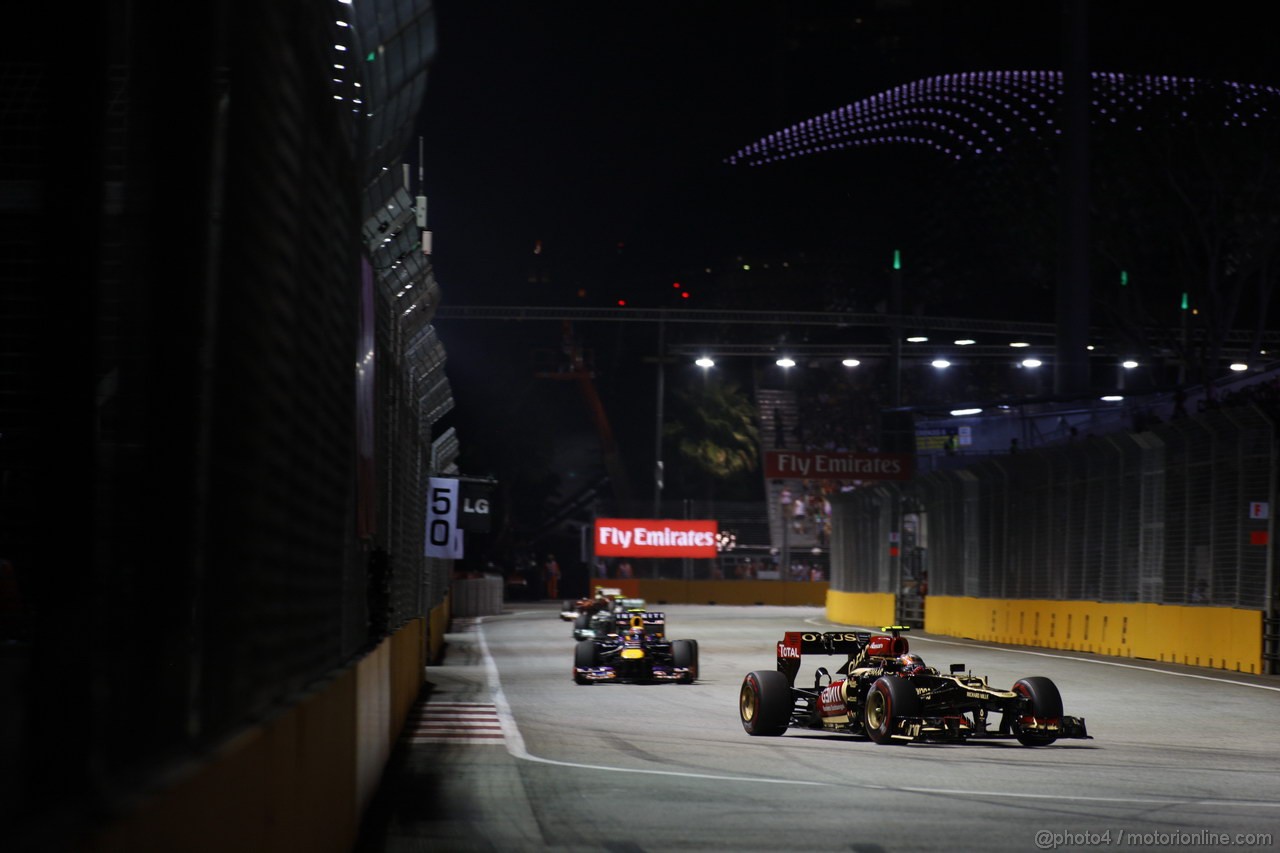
739, 625, 1089, 747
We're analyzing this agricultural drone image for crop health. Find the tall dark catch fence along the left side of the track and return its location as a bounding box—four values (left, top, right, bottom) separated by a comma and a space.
0, 3, 456, 824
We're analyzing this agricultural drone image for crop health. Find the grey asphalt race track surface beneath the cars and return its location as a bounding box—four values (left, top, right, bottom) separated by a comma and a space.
360, 603, 1280, 853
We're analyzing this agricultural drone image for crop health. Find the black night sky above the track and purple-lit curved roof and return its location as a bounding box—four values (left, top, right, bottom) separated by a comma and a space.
410, 0, 1280, 537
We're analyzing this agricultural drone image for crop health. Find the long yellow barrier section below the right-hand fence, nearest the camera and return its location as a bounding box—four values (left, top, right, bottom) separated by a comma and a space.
921, 593, 1263, 674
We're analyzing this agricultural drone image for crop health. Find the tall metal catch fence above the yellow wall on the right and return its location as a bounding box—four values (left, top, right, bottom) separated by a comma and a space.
832, 405, 1276, 611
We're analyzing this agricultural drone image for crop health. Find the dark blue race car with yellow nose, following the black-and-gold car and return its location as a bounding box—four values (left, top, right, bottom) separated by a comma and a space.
573, 610, 698, 684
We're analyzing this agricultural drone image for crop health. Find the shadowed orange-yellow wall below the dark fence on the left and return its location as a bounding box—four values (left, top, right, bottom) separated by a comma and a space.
87, 601, 448, 853
